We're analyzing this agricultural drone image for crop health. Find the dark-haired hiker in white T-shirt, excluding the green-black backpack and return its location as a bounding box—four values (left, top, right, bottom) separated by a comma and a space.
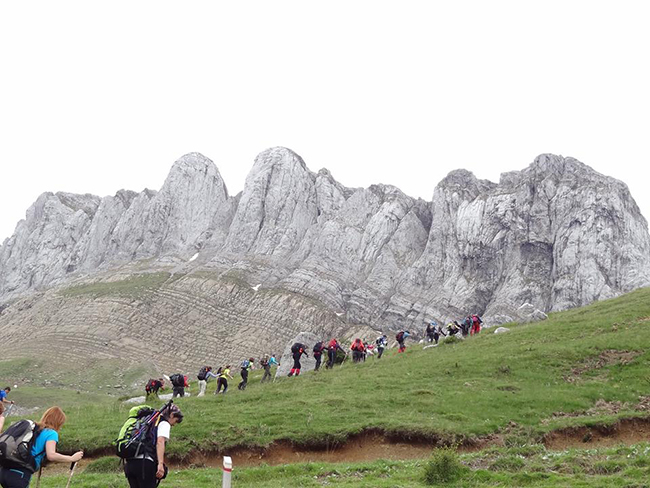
124, 404, 183, 488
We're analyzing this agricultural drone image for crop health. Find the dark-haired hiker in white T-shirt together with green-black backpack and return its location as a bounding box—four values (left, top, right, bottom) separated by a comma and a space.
117, 401, 183, 488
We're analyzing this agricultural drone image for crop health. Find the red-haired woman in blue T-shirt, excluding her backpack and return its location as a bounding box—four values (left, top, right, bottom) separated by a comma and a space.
0, 407, 84, 488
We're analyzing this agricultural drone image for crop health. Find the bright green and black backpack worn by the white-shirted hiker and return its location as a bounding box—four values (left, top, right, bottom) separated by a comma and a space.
115, 405, 160, 460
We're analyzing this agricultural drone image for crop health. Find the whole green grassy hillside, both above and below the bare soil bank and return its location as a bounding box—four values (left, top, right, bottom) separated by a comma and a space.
0, 289, 650, 487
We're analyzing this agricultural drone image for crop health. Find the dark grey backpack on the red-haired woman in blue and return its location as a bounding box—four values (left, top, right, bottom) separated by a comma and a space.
0, 420, 42, 473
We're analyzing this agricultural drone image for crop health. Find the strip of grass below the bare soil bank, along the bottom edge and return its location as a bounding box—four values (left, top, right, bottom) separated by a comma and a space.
36, 444, 650, 488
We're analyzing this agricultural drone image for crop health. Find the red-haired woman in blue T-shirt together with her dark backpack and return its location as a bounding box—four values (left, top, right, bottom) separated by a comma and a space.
0, 407, 84, 488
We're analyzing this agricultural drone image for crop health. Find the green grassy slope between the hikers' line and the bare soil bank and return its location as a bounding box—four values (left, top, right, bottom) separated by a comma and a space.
39, 289, 650, 456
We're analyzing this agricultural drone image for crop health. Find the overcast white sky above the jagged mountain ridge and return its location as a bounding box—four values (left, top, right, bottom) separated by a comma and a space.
0, 0, 650, 242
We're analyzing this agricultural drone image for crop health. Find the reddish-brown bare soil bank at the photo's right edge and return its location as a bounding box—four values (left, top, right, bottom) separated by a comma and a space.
544, 418, 650, 450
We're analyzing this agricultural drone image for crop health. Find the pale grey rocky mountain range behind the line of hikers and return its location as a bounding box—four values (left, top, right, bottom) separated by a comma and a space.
0, 147, 650, 368
